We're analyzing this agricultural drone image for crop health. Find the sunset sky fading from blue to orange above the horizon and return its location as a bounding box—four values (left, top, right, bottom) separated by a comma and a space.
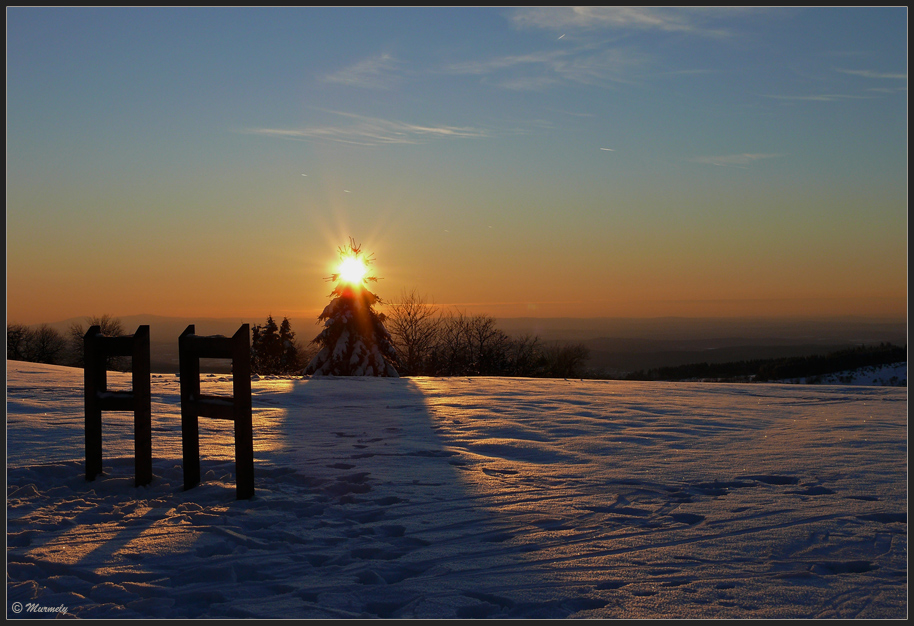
6, 7, 908, 324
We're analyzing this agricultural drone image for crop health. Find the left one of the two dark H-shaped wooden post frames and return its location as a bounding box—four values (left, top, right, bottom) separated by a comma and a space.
83, 325, 152, 487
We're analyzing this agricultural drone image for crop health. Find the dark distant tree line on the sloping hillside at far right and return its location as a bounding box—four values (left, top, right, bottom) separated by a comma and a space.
625, 343, 908, 382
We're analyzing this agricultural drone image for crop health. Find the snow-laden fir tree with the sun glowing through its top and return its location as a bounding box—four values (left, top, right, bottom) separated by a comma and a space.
304, 238, 398, 376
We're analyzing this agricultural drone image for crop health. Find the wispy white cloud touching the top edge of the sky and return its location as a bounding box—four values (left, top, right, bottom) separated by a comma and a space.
510, 7, 732, 37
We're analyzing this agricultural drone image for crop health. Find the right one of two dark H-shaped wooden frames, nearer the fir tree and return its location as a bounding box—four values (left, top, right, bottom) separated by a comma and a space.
178, 324, 254, 500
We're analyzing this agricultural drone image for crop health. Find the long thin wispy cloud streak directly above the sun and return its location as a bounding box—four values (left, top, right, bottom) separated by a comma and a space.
244, 111, 489, 146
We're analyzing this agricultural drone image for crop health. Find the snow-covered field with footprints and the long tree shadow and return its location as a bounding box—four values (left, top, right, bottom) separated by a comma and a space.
7, 362, 908, 618
